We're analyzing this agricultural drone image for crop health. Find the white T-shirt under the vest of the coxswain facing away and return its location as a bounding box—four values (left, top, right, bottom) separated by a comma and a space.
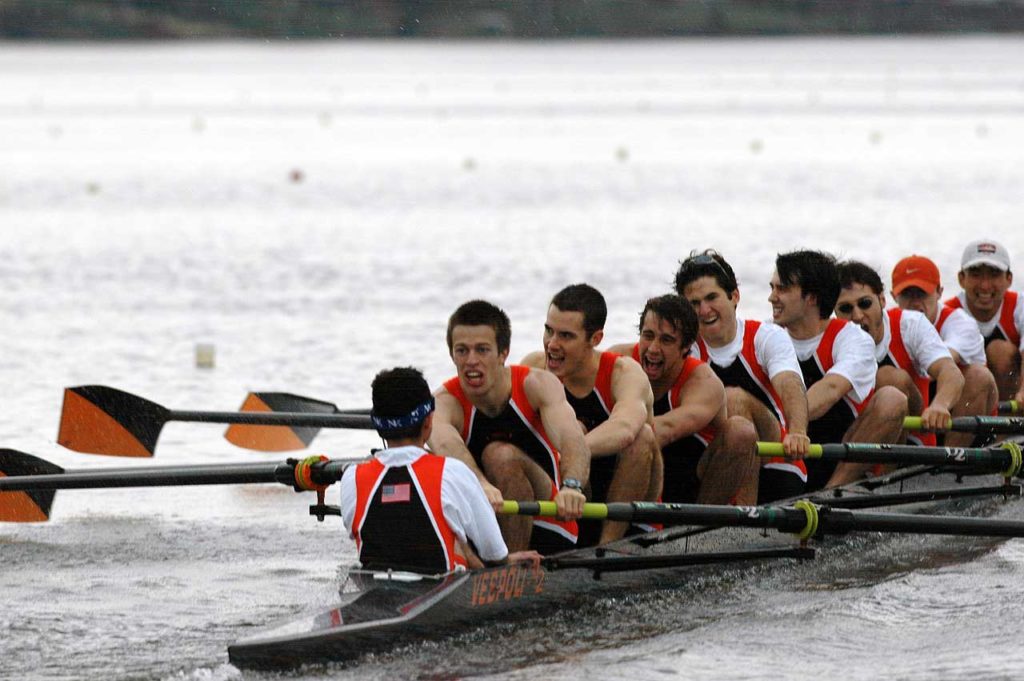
341, 446, 509, 561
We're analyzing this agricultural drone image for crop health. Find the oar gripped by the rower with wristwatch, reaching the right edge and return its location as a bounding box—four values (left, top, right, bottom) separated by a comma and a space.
503, 501, 1024, 539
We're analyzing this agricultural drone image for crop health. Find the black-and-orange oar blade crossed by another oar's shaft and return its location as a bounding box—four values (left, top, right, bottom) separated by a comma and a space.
224, 392, 338, 452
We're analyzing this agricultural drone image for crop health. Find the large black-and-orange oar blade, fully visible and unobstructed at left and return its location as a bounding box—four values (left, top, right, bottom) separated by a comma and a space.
57, 385, 169, 457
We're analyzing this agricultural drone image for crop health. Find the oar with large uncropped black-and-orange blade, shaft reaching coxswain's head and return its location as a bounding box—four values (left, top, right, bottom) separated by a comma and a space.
57, 385, 373, 457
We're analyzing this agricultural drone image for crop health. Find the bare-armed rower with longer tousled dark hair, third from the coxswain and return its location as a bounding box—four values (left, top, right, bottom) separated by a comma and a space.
611, 294, 760, 506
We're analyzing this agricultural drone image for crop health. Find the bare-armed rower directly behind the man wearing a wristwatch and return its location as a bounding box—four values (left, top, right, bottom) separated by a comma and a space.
521, 284, 662, 546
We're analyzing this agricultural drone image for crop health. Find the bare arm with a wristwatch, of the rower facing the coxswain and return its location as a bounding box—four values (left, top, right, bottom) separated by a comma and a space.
522, 370, 590, 519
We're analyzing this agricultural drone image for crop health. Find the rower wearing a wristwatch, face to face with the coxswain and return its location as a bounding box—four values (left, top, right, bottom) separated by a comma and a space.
430, 300, 590, 553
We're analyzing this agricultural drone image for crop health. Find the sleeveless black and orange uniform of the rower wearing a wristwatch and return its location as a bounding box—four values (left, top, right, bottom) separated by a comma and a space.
444, 365, 579, 553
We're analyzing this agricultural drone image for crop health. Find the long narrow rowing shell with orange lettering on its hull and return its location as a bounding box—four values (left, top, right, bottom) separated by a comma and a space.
227, 467, 1020, 669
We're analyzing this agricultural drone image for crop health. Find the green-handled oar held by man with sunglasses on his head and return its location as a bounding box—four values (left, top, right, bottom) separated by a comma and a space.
758, 442, 1021, 477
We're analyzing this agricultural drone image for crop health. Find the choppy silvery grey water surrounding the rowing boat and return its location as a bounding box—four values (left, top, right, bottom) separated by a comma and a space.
0, 38, 1024, 679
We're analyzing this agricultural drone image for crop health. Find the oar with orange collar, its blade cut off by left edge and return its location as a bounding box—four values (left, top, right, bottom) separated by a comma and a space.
0, 450, 355, 522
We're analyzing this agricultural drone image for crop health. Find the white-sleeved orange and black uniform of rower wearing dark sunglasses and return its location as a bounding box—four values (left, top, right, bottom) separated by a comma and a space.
874, 307, 952, 446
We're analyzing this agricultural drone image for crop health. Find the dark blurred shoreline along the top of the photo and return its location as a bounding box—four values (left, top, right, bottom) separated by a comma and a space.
0, 0, 1024, 41
